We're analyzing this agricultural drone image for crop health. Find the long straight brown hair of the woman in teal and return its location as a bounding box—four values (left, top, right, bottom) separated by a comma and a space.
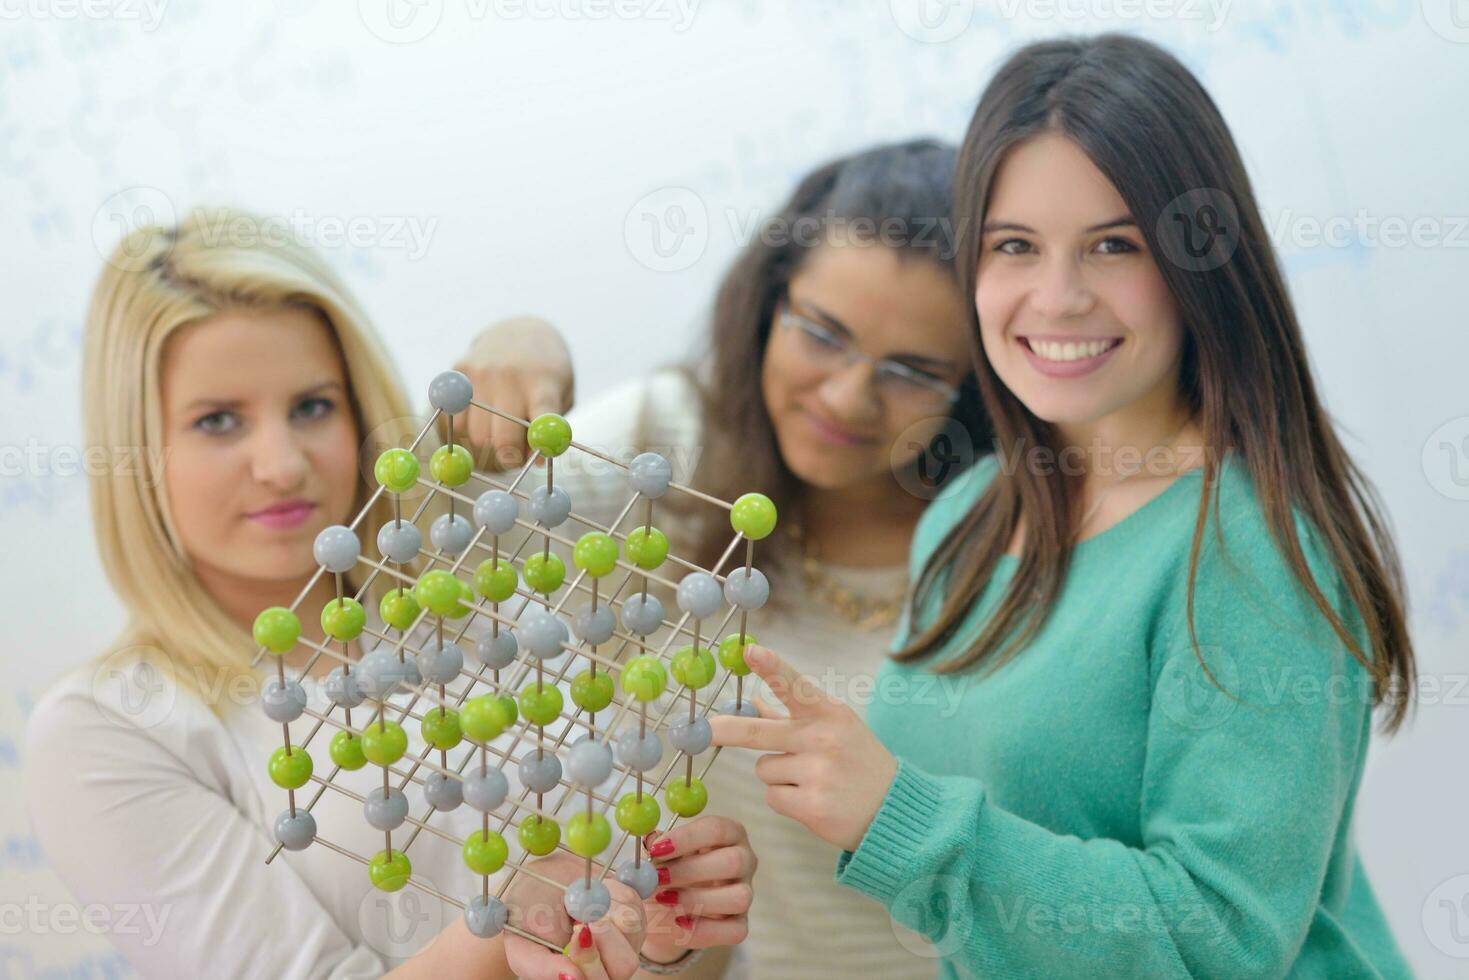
895, 34, 1413, 732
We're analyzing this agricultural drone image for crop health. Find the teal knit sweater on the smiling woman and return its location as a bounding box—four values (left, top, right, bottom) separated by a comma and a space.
836, 455, 1409, 979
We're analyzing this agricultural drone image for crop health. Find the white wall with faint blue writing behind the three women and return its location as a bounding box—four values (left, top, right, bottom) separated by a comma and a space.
0, 0, 1469, 977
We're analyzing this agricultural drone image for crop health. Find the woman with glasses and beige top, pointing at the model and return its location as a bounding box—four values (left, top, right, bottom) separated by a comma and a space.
452, 141, 989, 980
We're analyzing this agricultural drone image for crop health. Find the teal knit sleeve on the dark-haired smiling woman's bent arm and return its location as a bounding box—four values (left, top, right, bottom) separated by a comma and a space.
836, 502, 1371, 977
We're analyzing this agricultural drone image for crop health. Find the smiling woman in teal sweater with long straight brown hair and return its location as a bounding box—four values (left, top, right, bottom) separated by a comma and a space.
715, 35, 1413, 977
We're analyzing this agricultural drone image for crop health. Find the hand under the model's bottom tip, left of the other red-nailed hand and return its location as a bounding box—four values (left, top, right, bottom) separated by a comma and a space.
504, 852, 643, 980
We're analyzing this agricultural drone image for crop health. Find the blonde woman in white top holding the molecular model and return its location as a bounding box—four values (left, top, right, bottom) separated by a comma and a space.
25, 210, 752, 977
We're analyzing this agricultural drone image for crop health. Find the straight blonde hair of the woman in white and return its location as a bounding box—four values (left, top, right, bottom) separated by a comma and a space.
82, 207, 413, 699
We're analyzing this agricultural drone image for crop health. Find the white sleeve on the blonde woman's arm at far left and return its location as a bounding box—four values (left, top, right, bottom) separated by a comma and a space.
25, 686, 386, 980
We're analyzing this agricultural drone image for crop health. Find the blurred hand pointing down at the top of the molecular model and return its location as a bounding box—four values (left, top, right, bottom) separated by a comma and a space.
454, 316, 576, 472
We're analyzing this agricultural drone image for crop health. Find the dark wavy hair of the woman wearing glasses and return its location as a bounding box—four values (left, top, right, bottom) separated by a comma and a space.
672, 140, 992, 580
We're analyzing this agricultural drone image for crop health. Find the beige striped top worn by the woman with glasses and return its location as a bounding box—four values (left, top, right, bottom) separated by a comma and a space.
555, 372, 937, 980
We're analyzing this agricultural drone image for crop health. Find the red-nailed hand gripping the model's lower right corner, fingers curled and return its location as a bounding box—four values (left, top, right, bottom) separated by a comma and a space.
642, 811, 758, 962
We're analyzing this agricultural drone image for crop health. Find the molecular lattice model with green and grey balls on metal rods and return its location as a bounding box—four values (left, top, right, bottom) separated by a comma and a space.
254, 372, 776, 946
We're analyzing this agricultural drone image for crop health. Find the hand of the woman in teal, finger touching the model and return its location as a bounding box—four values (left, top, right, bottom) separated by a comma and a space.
710, 646, 898, 851
